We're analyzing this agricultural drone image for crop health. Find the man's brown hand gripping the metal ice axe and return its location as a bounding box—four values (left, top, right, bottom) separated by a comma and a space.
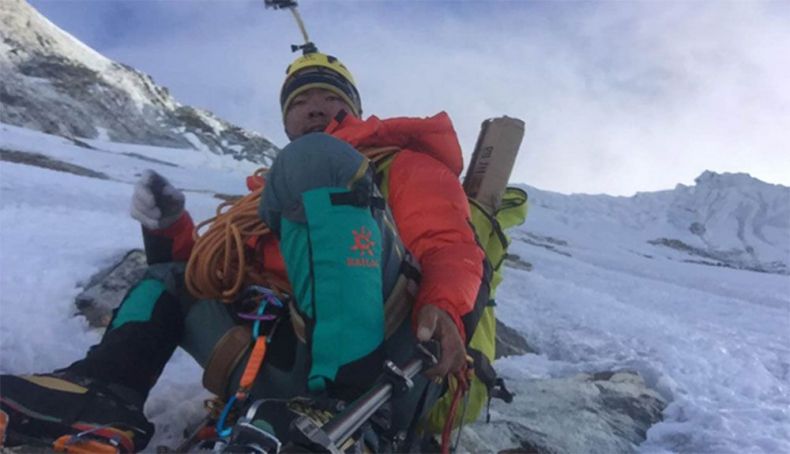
417, 304, 466, 378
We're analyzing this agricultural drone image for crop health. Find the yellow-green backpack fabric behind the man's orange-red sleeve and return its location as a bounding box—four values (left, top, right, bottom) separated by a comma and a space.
424, 187, 527, 433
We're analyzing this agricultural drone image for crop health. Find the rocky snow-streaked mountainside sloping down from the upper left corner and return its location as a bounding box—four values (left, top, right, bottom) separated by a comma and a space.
0, 0, 277, 164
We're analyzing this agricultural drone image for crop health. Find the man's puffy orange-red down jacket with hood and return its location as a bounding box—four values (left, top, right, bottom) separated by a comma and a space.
150, 112, 484, 339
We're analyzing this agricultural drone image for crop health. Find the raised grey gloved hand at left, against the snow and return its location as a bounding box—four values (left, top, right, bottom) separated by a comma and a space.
131, 169, 184, 230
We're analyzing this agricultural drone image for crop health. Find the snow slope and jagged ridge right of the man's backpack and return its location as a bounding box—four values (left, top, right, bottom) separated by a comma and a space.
482, 179, 790, 452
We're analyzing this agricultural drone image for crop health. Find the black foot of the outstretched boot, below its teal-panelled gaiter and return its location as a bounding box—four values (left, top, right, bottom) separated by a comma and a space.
0, 370, 154, 452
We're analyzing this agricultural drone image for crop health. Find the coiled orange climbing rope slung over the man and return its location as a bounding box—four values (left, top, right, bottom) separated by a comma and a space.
185, 147, 399, 303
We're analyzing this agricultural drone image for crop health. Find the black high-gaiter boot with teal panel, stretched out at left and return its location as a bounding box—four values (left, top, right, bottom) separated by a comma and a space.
0, 264, 189, 452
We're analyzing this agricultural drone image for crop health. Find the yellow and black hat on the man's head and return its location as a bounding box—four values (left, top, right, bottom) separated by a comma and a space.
280, 52, 362, 117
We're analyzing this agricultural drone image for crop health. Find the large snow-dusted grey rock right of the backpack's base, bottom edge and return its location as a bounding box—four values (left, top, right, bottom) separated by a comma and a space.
461, 371, 666, 454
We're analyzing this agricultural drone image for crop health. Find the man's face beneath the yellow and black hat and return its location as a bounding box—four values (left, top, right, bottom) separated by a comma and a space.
285, 88, 351, 140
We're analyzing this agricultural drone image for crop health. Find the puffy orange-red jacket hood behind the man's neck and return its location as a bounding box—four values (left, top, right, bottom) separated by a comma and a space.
325, 112, 464, 176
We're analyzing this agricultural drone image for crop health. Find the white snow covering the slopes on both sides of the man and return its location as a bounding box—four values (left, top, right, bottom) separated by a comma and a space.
0, 124, 790, 453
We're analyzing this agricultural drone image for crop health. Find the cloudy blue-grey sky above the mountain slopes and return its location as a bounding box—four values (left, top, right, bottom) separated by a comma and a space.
31, 0, 790, 195
